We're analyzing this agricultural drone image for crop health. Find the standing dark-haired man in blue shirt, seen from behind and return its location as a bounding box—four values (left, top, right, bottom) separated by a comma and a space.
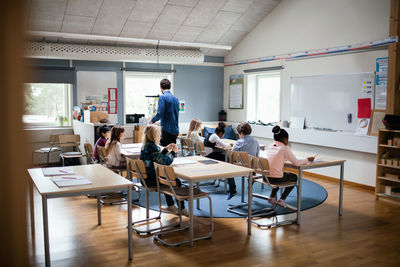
150, 79, 179, 146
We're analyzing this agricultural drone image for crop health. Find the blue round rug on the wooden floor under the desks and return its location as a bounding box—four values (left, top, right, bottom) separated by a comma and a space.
133, 177, 328, 218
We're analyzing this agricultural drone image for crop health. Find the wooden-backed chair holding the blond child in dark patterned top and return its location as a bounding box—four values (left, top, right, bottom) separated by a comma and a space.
126, 158, 180, 235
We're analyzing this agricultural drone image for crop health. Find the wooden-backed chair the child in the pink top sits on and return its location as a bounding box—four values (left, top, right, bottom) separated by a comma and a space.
251, 157, 299, 228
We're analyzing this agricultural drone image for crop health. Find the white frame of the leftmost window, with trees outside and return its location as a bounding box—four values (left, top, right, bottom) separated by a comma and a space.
22, 82, 74, 129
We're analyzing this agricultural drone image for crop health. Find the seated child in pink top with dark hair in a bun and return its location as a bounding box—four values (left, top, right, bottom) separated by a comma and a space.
267, 126, 314, 208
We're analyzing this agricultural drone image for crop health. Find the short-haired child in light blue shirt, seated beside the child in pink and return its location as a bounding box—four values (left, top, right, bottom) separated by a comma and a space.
227, 122, 260, 200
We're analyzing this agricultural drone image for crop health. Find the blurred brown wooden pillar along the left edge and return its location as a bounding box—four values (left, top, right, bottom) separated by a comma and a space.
0, 0, 29, 266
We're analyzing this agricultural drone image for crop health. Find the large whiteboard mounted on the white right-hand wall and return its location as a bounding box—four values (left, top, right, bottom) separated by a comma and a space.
290, 72, 375, 132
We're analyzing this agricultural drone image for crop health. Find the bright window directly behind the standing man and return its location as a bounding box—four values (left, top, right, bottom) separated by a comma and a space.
124, 72, 172, 118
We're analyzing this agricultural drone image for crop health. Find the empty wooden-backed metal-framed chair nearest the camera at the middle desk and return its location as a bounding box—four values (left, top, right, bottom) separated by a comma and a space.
154, 163, 214, 246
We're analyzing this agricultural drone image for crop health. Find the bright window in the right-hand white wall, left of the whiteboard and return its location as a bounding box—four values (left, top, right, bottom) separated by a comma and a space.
247, 72, 281, 123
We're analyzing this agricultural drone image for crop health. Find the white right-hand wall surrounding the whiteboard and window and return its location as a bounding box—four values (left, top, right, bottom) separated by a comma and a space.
224, 0, 390, 186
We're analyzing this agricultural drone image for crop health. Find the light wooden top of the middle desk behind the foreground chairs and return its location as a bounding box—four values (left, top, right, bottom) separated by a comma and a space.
172, 156, 253, 180
